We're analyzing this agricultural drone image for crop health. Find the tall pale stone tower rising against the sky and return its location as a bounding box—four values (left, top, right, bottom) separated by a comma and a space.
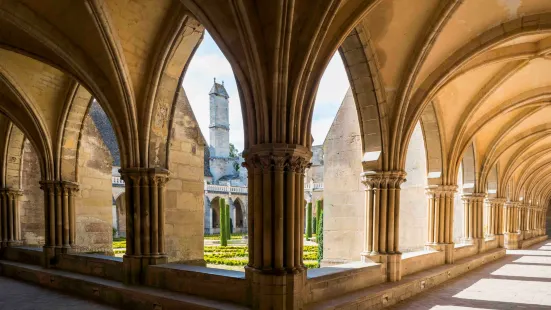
209, 79, 230, 158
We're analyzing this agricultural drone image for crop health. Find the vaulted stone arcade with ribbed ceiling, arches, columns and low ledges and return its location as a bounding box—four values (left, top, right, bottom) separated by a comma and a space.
0, 0, 551, 309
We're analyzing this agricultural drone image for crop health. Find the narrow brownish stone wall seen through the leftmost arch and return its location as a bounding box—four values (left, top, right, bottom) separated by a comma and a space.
19, 140, 45, 245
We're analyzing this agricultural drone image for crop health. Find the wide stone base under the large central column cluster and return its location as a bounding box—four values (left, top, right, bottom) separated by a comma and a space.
245, 266, 306, 310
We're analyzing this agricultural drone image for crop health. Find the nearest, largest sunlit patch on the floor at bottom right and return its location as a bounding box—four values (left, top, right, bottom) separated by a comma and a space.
453, 278, 551, 306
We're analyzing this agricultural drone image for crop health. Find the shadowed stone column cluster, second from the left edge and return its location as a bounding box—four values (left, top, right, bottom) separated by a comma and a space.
40, 180, 78, 268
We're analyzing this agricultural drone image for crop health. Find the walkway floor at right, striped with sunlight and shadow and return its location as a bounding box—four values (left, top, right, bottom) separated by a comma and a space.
391, 240, 551, 310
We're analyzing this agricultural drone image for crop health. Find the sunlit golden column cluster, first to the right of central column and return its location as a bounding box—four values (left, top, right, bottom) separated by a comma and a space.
361, 171, 406, 282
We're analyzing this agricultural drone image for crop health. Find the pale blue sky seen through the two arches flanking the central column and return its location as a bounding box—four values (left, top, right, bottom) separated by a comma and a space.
183, 32, 349, 151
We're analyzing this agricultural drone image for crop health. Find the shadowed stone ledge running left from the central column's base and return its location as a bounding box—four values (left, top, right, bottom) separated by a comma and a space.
145, 264, 247, 305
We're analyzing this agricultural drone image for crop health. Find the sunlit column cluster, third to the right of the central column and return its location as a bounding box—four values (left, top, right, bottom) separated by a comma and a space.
461, 193, 486, 251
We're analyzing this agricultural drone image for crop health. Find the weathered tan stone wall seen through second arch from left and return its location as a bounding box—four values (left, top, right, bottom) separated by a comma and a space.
75, 115, 113, 254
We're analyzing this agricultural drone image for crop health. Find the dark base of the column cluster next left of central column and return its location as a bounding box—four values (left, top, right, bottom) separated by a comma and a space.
122, 255, 168, 284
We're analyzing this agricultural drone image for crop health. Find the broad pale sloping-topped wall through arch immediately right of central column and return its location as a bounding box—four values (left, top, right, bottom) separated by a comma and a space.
323, 90, 365, 264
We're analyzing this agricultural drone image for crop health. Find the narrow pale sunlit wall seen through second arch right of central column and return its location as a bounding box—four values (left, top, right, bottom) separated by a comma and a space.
399, 123, 428, 252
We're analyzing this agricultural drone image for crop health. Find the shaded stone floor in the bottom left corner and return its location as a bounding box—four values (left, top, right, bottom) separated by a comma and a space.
0, 277, 115, 310
